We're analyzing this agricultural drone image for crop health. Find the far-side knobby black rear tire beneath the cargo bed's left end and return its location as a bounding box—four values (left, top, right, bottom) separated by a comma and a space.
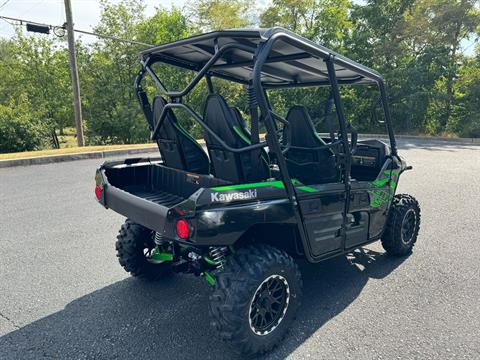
115, 219, 171, 280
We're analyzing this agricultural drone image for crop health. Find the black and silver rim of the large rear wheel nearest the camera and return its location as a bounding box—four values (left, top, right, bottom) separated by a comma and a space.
249, 275, 290, 335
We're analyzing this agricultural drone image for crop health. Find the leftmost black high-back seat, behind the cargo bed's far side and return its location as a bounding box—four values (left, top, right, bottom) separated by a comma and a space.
152, 96, 210, 174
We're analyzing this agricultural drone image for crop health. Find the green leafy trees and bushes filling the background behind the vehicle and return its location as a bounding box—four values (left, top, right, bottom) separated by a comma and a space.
0, 0, 480, 151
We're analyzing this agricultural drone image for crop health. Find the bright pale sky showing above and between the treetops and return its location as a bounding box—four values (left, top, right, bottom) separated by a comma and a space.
0, 0, 475, 55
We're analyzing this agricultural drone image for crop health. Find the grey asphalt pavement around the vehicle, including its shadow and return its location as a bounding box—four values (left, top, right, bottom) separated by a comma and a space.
0, 143, 480, 360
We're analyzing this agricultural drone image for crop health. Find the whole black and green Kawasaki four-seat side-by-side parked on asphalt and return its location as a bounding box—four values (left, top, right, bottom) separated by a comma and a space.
95, 28, 420, 354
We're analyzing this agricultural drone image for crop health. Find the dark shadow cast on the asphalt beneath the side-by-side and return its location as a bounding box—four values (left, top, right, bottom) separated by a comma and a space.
0, 249, 404, 359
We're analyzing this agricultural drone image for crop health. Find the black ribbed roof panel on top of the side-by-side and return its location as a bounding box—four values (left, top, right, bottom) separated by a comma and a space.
141, 27, 382, 87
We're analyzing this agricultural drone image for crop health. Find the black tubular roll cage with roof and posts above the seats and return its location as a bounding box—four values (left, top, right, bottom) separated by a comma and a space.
135, 27, 397, 262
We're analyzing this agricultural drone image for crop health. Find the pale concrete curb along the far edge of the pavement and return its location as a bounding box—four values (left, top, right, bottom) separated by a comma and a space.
0, 134, 480, 168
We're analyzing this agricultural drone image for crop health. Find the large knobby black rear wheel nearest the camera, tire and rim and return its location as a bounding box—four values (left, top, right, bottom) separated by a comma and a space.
210, 244, 302, 356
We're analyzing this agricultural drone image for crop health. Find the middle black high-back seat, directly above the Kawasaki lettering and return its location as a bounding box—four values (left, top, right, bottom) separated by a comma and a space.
204, 94, 270, 184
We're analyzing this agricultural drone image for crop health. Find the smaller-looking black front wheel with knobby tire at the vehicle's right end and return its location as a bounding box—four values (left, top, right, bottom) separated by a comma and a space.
382, 194, 420, 256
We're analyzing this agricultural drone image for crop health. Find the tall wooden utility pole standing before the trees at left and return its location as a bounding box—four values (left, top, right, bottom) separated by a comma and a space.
65, 0, 85, 146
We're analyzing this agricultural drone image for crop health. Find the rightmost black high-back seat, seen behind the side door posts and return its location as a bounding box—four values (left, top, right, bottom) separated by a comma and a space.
283, 105, 340, 184
